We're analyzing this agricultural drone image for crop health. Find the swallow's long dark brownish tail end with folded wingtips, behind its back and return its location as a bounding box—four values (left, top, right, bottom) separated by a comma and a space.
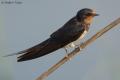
18, 39, 63, 62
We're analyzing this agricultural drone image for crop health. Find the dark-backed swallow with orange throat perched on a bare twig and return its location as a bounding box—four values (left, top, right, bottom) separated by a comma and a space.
4, 8, 99, 62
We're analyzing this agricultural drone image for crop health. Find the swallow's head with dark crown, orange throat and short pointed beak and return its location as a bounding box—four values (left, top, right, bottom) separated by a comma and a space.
76, 8, 99, 24
